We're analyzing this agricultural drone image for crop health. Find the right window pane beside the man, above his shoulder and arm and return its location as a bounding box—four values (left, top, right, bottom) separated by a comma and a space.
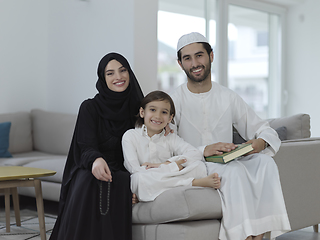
228, 5, 278, 118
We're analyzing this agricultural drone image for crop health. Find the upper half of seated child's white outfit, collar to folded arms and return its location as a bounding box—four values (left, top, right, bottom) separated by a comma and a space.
122, 125, 204, 173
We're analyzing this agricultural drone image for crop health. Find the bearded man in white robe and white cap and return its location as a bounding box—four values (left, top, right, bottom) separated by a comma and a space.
172, 33, 290, 240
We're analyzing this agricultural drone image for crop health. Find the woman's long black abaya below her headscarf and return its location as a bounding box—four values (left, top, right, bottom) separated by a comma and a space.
50, 100, 132, 240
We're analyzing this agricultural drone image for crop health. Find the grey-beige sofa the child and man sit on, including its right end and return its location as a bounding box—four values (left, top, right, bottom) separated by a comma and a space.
133, 114, 320, 240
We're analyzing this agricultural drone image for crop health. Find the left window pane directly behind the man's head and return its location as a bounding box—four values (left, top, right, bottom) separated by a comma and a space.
158, 0, 216, 92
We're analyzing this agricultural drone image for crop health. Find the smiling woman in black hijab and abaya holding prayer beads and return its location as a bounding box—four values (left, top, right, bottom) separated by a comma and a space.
50, 53, 143, 240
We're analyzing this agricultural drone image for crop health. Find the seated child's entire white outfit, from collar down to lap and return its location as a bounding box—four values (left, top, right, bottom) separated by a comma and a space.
122, 125, 207, 202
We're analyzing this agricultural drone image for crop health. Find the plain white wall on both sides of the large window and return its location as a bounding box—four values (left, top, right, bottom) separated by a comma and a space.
0, 0, 320, 136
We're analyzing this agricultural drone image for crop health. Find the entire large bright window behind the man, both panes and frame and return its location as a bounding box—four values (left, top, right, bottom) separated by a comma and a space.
158, 0, 284, 118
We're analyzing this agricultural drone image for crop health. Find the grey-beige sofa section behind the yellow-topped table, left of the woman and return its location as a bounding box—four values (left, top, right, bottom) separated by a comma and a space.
0, 109, 76, 201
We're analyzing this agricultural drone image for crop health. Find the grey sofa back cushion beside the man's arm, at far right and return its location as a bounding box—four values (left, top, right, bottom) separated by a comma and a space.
268, 113, 311, 140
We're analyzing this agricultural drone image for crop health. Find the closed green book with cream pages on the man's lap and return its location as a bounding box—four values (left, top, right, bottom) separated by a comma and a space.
205, 143, 253, 163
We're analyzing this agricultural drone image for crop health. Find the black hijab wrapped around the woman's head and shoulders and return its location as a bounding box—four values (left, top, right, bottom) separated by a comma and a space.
94, 53, 143, 136
